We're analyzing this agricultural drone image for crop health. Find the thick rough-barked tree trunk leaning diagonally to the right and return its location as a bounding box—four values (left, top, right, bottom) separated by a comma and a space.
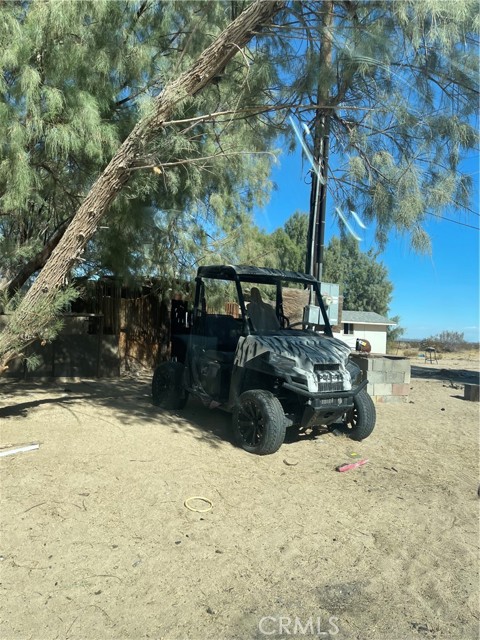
0, 0, 285, 373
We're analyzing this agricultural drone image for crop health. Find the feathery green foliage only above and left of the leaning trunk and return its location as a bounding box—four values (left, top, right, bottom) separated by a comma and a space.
0, 1, 154, 291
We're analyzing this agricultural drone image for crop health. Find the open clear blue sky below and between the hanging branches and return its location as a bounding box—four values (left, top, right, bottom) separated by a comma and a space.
255, 152, 480, 342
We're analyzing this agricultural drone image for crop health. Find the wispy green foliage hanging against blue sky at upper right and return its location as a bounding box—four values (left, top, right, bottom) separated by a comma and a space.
281, 0, 479, 251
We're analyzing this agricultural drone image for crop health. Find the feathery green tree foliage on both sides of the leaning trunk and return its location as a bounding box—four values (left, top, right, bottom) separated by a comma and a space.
0, 0, 282, 294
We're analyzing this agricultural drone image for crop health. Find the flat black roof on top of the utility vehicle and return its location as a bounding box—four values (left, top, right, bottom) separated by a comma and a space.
197, 264, 316, 284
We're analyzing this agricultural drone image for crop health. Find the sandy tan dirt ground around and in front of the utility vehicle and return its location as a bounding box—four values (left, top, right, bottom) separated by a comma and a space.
0, 359, 480, 640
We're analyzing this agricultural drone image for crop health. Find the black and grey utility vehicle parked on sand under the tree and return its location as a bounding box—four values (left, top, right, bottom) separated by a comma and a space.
152, 265, 375, 454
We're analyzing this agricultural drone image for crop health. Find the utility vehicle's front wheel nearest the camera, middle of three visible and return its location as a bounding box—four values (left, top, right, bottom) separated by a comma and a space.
233, 390, 287, 455
